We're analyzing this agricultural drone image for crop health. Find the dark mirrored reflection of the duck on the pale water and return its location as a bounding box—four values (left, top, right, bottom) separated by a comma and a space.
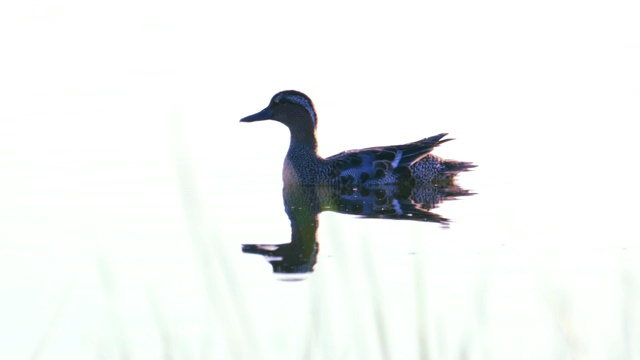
242, 179, 472, 280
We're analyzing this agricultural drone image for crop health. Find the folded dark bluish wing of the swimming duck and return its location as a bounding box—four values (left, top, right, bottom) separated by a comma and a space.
326, 133, 453, 185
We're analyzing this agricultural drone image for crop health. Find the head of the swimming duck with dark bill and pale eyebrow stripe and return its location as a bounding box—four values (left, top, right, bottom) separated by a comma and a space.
240, 90, 318, 129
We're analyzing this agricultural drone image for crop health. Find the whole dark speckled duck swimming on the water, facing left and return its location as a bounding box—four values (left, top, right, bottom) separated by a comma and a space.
240, 90, 475, 187
